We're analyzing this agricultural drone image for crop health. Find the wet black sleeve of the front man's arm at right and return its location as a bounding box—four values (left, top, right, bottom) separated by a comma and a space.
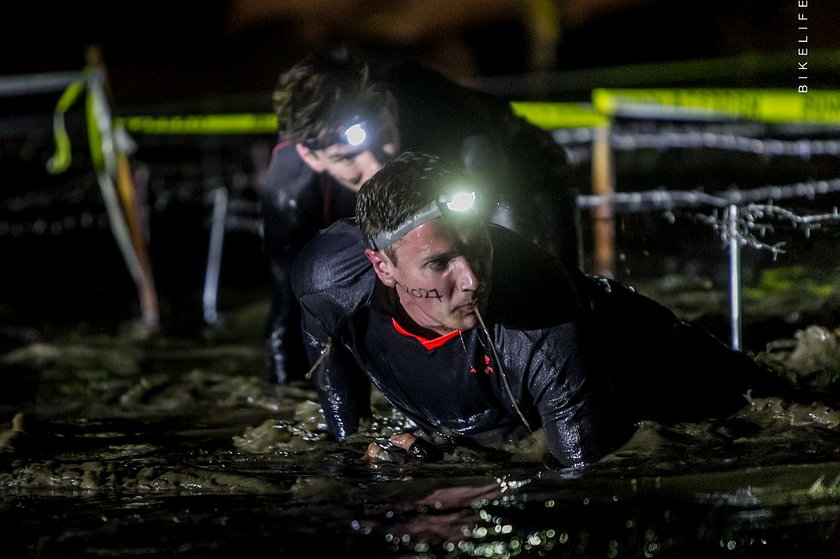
528, 322, 630, 467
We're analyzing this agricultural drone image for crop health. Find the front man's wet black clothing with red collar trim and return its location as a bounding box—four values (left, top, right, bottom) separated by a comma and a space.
293, 221, 758, 466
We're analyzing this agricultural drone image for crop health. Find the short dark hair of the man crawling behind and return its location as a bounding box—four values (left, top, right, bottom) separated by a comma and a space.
272, 52, 388, 149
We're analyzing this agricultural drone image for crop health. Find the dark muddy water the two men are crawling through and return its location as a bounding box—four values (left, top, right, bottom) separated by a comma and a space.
0, 289, 840, 558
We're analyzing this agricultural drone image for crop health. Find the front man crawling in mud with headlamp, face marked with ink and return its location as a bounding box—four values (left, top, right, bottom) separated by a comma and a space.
293, 152, 796, 467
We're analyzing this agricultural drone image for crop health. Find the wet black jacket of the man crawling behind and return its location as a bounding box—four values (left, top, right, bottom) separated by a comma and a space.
262, 64, 580, 383
